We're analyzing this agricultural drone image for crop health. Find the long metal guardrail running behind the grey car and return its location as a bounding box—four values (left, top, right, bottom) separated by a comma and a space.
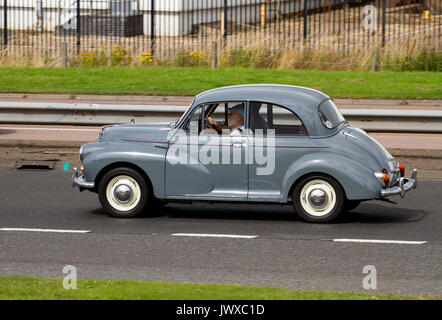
0, 102, 442, 133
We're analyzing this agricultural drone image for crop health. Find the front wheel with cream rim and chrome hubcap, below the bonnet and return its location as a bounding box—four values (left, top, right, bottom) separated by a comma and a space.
98, 168, 149, 218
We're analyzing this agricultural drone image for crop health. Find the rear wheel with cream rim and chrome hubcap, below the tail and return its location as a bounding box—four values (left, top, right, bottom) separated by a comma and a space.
292, 175, 345, 223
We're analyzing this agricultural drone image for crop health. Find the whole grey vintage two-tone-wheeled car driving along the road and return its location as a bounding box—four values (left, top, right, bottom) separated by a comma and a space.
72, 85, 417, 222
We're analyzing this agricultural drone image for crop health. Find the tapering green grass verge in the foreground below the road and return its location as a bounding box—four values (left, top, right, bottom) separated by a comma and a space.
0, 277, 441, 300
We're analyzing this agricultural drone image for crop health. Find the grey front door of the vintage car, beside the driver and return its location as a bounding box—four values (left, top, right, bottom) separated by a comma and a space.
166, 102, 248, 201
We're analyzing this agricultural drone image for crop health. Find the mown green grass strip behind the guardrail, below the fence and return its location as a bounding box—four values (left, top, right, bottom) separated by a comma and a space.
0, 67, 442, 99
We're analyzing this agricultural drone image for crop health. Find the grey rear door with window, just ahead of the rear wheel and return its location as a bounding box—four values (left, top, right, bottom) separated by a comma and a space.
248, 102, 311, 202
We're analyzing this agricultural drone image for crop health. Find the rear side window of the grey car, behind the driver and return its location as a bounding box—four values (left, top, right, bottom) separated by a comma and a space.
249, 102, 307, 136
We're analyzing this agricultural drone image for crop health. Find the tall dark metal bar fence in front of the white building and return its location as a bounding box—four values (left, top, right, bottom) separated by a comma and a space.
0, 0, 442, 64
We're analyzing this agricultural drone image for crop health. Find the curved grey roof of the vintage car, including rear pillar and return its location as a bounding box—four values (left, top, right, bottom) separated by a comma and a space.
192, 84, 330, 136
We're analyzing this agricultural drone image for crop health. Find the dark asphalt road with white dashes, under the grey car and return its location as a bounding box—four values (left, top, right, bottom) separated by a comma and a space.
0, 169, 442, 296
